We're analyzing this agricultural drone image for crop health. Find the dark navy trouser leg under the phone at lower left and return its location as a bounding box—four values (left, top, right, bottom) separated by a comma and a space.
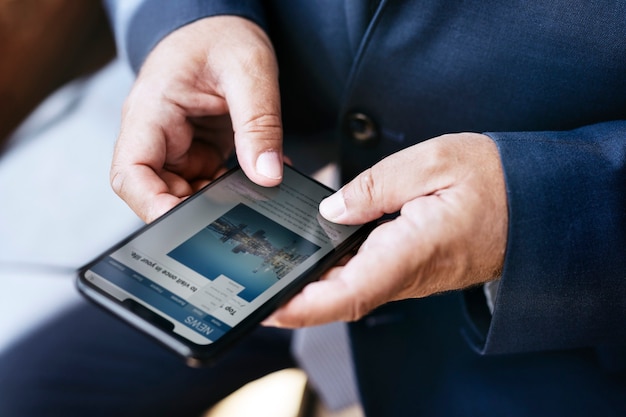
0, 302, 295, 417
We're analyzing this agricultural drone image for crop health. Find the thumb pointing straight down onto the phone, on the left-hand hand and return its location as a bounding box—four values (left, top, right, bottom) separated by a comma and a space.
217, 20, 283, 186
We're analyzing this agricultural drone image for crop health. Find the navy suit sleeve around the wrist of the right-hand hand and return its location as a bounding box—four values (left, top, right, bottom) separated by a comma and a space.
460, 121, 626, 354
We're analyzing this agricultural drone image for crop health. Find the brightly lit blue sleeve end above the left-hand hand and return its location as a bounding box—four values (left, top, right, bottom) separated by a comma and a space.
105, 0, 265, 72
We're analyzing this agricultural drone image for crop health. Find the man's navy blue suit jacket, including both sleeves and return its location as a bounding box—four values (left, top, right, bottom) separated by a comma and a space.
105, 0, 626, 416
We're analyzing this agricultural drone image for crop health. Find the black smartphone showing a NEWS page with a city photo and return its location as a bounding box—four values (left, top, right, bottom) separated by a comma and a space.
77, 166, 373, 366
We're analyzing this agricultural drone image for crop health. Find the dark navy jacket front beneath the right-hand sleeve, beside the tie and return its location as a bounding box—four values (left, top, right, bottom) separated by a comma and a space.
350, 293, 626, 417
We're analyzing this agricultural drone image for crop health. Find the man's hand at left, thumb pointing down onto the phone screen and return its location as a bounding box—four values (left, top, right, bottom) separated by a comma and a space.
111, 16, 283, 222
